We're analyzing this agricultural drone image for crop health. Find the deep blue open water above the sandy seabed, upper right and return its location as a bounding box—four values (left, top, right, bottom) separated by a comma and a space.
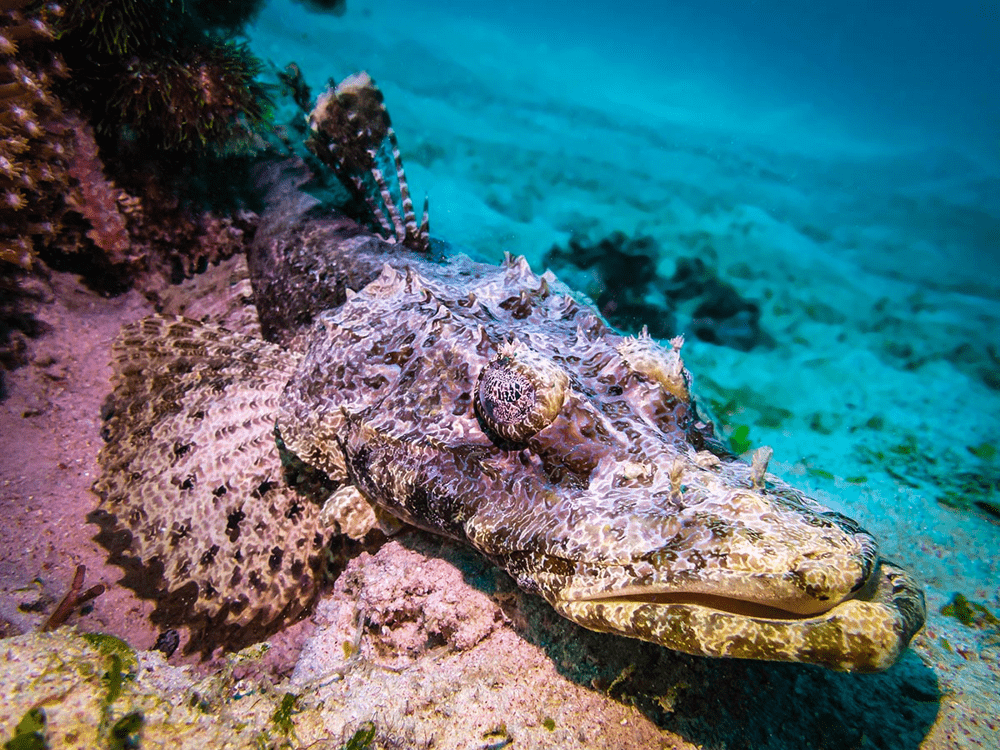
448, 0, 1000, 159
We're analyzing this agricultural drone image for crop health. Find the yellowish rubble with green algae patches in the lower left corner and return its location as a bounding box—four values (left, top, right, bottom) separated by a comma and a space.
0, 628, 340, 750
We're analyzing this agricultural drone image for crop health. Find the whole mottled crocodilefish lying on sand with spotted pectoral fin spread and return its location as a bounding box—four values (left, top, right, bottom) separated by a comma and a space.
97, 72, 924, 671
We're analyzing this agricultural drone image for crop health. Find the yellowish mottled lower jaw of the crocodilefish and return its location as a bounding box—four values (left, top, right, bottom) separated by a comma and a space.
552, 560, 926, 672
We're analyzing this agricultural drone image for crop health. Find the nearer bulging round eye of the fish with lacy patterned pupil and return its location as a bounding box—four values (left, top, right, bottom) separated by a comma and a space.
475, 341, 569, 443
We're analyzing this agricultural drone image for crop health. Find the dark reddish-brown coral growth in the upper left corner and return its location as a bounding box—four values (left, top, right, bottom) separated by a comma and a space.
0, 0, 268, 275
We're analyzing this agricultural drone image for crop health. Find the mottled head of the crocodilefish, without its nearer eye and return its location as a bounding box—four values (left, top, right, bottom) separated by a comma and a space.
251, 198, 924, 671
